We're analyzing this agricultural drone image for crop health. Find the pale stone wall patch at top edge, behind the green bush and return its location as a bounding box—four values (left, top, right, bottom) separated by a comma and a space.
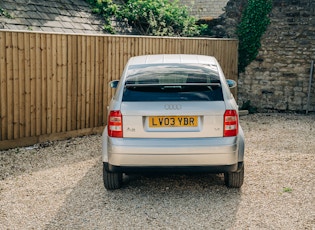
179, 0, 228, 19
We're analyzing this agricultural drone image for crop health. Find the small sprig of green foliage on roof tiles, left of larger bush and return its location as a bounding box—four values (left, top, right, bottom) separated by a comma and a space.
86, 0, 118, 34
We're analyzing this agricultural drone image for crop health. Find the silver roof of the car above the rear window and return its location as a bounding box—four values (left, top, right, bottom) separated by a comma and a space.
129, 54, 217, 65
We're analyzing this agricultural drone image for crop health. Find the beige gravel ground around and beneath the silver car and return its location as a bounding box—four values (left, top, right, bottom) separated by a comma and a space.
0, 114, 315, 229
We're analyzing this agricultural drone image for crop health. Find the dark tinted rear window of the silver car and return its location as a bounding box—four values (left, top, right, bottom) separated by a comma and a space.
123, 64, 223, 101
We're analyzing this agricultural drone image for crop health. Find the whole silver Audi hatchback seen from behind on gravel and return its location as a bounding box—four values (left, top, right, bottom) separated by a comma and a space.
102, 54, 244, 190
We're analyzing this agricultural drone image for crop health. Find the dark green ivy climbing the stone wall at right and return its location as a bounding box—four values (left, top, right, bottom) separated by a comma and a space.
237, 0, 272, 72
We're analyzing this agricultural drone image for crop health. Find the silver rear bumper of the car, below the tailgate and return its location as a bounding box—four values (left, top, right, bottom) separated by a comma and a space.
104, 137, 238, 172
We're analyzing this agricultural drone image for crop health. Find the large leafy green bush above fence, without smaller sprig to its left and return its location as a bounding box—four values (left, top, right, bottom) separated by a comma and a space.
119, 0, 206, 36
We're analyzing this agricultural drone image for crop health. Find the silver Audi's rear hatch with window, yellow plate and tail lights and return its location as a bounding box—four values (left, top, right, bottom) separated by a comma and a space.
109, 61, 235, 138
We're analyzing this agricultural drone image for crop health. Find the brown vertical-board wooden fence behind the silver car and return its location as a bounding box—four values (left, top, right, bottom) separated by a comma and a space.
0, 31, 238, 149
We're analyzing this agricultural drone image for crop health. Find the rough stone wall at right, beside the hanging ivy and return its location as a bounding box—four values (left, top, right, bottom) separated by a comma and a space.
238, 0, 315, 111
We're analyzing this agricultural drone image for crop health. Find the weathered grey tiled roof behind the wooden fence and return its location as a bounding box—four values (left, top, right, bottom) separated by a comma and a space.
0, 0, 131, 34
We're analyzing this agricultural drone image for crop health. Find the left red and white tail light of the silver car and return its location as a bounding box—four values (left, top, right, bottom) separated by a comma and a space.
107, 110, 123, 137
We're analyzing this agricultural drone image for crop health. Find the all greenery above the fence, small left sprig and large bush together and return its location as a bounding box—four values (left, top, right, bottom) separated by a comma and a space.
86, 0, 207, 36
